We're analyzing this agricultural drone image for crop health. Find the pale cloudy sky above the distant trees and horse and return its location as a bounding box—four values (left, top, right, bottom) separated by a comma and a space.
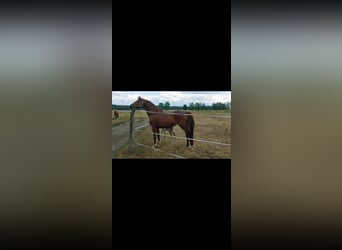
112, 91, 231, 106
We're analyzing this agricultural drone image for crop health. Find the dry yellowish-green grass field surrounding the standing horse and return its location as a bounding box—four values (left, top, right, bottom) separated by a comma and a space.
112, 111, 231, 159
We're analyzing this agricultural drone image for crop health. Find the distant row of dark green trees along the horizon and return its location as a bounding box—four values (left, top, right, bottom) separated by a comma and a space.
112, 102, 231, 110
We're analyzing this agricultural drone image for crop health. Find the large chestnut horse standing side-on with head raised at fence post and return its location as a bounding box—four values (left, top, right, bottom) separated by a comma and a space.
130, 96, 195, 147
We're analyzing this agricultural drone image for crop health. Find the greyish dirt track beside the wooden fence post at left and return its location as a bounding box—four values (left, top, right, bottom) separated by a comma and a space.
112, 121, 146, 158
